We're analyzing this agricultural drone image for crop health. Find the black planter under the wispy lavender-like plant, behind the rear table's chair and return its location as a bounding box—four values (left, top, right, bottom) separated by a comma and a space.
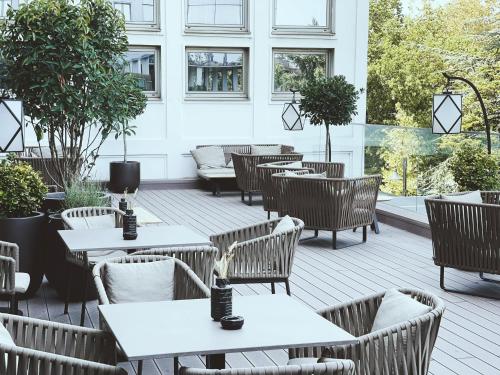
44, 214, 97, 301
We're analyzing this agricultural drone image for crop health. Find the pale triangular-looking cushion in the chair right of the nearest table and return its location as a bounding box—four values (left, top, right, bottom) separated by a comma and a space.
372, 289, 431, 332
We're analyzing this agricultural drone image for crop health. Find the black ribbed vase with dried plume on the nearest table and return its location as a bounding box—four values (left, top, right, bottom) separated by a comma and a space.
210, 242, 237, 322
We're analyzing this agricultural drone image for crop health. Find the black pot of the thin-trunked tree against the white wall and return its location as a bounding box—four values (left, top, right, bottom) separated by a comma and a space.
108, 161, 141, 193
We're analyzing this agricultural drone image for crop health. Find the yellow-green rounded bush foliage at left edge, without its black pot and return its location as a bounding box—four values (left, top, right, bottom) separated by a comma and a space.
0, 158, 47, 218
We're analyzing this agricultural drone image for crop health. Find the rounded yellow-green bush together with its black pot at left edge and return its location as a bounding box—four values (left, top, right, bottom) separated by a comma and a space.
0, 157, 47, 296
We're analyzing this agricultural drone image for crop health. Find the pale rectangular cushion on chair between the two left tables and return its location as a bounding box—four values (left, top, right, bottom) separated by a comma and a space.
102, 259, 175, 303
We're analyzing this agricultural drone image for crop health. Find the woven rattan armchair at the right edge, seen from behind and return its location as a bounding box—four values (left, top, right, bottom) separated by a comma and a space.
425, 191, 500, 289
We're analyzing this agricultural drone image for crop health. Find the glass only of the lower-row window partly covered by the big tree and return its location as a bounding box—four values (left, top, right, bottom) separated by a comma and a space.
124, 51, 156, 91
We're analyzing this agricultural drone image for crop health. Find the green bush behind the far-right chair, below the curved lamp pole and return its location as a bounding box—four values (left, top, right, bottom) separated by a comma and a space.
449, 139, 500, 191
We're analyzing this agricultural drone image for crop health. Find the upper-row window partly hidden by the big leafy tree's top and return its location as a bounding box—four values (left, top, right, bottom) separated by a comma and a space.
111, 0, 159, 28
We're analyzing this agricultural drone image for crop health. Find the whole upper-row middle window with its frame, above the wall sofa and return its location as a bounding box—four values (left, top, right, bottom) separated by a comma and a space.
185, 0, 248, 32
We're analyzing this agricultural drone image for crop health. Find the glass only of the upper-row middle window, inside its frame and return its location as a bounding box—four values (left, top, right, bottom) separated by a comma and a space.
187, 0, 243, 26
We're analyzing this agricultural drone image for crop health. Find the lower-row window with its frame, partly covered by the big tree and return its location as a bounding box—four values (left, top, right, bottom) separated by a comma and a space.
124, 47, 160, 98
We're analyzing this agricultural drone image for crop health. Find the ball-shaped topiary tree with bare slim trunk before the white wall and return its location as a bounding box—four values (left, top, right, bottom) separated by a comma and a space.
300, 75, 362, 161
